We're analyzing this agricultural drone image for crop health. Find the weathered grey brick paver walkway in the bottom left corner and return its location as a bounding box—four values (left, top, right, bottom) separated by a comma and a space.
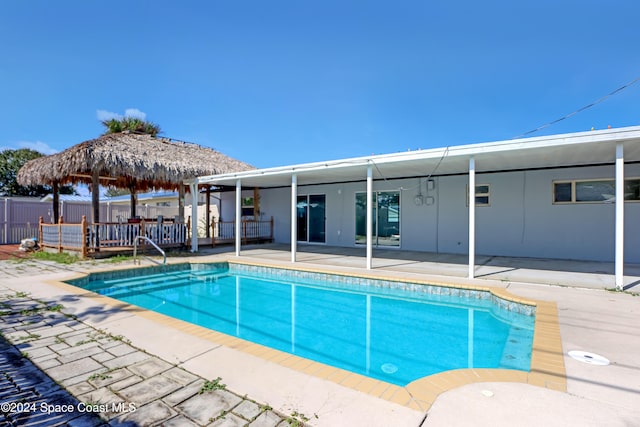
0, 282, 284, 427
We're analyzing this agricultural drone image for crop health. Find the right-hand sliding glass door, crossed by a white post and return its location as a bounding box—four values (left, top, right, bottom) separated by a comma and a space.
355, 191, 400, 246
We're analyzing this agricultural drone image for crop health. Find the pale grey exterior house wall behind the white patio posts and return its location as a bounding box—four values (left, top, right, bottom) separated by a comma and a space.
223, 164, 640, 263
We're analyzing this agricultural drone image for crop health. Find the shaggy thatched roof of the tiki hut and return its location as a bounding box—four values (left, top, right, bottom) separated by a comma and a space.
17, 133, 254, 227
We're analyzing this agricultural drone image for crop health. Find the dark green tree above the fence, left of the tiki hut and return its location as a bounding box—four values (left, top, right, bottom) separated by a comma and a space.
0, 148, 76, 197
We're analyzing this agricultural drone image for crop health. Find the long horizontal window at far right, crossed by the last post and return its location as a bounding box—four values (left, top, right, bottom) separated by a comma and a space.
553, 178, 640, 204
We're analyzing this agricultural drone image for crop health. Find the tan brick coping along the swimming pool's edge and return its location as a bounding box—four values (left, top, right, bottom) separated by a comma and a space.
47, 259, 567, 411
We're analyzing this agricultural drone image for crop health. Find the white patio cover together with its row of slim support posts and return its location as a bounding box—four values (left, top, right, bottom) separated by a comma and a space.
188, 126, 640, 289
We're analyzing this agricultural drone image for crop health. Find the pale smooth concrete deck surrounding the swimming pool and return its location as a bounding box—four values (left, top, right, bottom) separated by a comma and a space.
0, 245, 640, 426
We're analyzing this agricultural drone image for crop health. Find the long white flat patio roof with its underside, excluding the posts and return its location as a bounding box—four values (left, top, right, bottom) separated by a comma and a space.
197, 126, 640, 188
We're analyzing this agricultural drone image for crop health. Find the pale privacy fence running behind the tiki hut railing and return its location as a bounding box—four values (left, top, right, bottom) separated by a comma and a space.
0, 197, 178, 244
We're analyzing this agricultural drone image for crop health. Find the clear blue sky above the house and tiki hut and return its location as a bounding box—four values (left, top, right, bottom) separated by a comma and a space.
0, 0, 640, 167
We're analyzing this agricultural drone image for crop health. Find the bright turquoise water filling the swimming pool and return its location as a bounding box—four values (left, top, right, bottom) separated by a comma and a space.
69, 263, 535, 385
